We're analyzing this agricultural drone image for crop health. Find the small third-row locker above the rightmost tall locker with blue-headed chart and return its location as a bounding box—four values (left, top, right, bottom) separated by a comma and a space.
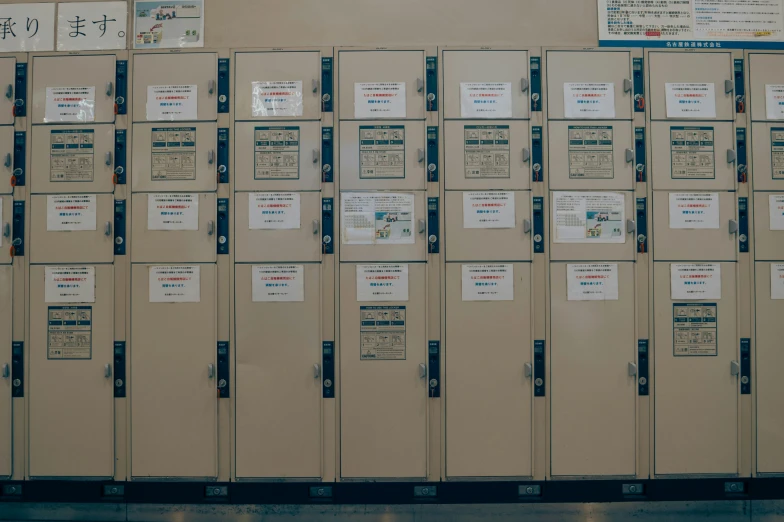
653, 191, 738, 261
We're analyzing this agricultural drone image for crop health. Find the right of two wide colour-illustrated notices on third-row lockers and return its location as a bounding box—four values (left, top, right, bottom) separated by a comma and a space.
553, 192, 626, 243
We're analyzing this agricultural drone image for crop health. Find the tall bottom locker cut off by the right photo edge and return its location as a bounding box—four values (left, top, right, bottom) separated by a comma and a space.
755, 263, 784, 473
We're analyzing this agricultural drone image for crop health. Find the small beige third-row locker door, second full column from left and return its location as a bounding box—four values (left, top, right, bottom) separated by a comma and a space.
131, 193, 218, 263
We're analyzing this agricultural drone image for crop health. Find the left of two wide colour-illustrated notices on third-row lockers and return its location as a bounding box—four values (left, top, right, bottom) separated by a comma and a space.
340, 192, 415, 245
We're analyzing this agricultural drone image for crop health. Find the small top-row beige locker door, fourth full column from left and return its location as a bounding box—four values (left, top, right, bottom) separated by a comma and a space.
338, 51, 425, 120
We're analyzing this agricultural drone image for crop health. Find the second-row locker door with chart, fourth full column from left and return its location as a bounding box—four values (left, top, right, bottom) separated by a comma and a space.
340, 121, 427, 190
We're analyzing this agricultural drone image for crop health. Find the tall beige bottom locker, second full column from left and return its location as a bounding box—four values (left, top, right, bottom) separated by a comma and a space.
130, 264, 218, 478
